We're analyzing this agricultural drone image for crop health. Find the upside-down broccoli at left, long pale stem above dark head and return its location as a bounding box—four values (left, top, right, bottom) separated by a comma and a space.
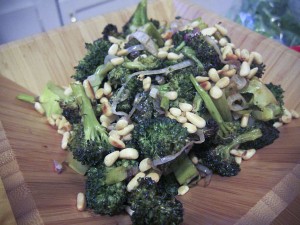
68, 83, 113, 166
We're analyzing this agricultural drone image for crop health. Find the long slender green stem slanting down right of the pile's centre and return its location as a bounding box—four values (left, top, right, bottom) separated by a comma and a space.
190, 74, 229, 136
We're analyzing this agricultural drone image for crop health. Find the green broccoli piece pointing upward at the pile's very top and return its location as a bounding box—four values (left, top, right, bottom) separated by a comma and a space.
123, 0, 149, 35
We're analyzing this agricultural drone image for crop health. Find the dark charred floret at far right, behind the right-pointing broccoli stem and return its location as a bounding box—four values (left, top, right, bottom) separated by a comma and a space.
239, 121, 280, 149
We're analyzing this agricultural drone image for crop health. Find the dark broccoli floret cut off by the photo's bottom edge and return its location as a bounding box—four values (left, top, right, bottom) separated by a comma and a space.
128, 178, 183, 225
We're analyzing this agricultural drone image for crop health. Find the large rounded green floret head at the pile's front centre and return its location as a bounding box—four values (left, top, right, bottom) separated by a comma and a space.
133, 117, 188, 159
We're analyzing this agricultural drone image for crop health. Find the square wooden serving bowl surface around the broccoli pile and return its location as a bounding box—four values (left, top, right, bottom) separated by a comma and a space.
0, 0, 300, 225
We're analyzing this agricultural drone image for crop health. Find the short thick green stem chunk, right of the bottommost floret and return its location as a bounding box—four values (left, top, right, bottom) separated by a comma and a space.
172, 154, 199, 185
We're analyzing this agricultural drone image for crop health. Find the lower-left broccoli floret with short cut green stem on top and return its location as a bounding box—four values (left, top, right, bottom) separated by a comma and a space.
86, 160, 137, 216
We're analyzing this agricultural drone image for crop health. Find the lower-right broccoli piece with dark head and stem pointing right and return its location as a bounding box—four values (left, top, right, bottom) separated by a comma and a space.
195, 129, 262, 176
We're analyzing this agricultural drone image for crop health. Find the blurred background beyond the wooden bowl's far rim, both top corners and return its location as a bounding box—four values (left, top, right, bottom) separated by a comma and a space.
0, 0, 300, 46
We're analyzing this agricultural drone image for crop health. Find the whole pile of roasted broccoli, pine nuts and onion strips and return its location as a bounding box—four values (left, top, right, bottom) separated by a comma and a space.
18, 0, 298, 225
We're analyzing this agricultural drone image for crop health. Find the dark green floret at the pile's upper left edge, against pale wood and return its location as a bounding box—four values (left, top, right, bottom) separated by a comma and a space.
72, 38, 111, 82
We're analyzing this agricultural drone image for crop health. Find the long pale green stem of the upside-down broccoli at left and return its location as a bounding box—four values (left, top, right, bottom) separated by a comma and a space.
71, 83, 108, 143
